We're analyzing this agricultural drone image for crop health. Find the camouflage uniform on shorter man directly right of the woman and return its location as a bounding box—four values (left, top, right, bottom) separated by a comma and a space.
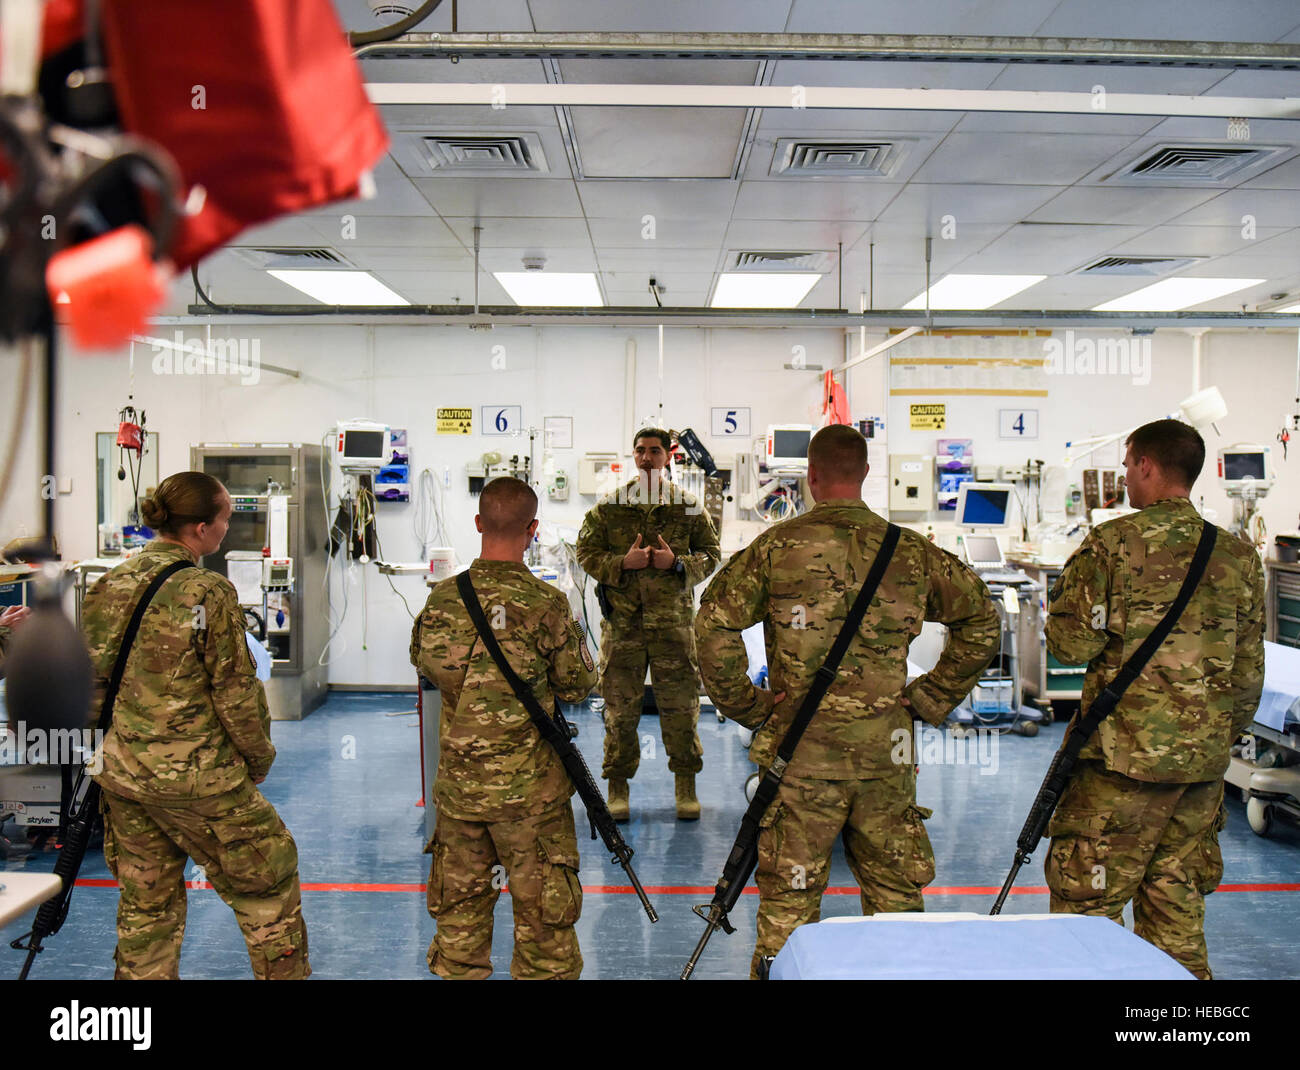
411, 558, 595, 979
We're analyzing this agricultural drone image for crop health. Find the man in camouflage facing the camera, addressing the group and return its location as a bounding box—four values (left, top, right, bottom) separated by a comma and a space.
577, 428, 722, 822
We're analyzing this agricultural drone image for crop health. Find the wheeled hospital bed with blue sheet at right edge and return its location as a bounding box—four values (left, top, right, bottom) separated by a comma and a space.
1223, 642, 1300, 836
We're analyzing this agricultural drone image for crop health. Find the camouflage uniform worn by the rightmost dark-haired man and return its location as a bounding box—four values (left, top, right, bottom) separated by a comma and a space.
1045, 498, 1264, 979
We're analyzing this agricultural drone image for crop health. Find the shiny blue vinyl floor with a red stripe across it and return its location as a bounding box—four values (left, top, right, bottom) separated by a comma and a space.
0, 693, 1300, 979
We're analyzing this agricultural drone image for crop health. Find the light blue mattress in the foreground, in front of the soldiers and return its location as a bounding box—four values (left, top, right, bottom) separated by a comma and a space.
772, 914, 1193, 980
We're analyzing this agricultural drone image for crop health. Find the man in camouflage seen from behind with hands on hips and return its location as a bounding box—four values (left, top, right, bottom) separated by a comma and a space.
696, 425, 998, 975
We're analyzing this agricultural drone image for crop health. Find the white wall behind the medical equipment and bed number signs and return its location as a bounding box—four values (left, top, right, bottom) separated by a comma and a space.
0, 324, 1300, 685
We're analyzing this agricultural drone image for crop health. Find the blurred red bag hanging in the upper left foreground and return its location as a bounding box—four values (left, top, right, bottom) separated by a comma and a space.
101, 0, 387, 269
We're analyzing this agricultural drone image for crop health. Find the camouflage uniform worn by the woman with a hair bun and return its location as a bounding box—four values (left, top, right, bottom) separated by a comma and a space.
82, 540, 311, 979
